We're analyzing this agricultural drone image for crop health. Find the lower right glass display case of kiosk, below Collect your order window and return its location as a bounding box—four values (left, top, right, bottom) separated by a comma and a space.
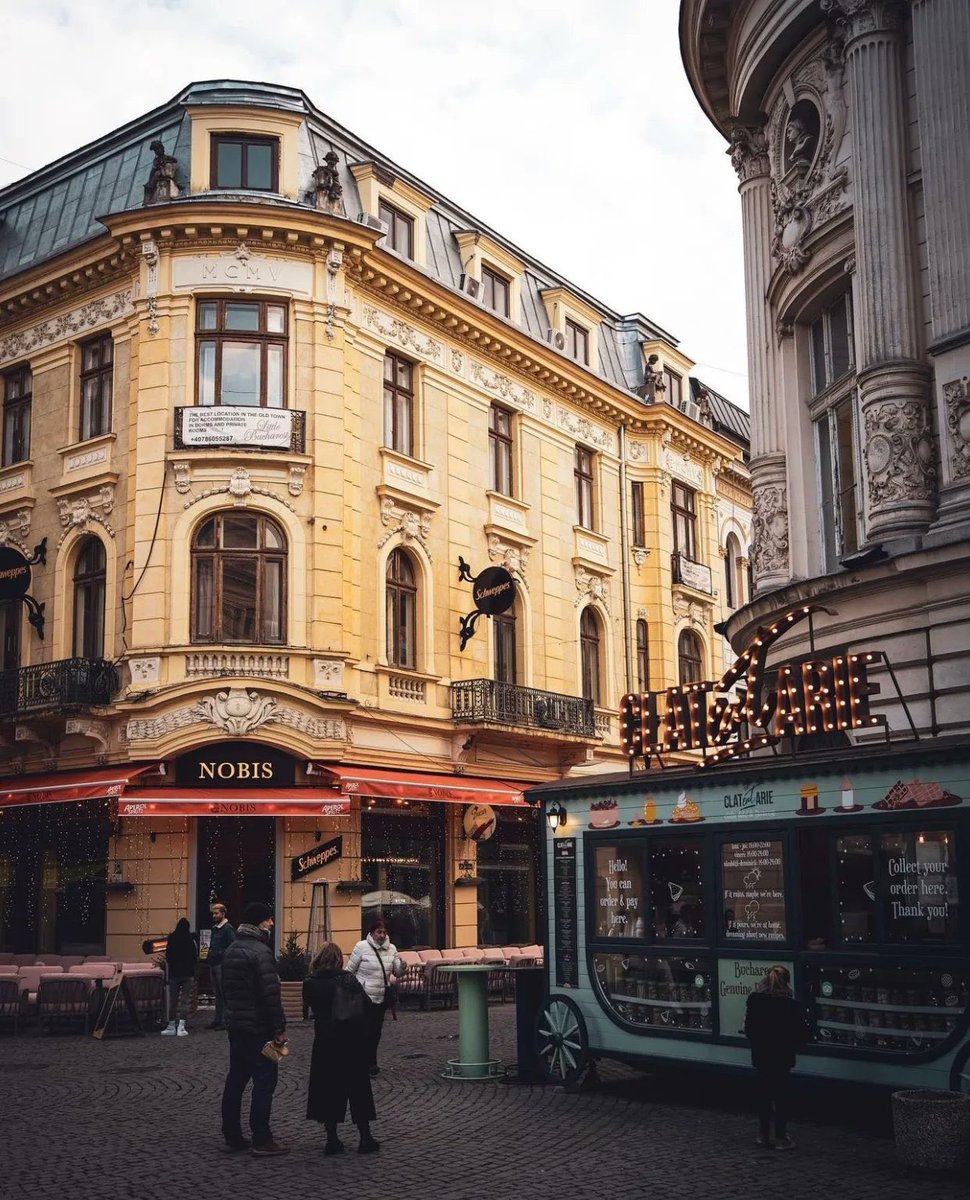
807, 964, 970, 1055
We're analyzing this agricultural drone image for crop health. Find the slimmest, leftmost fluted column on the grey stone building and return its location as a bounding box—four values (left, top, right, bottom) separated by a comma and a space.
729, 126, 790, 592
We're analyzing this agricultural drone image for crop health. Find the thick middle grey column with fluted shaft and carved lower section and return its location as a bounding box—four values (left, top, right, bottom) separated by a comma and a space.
821, 0, 936, 540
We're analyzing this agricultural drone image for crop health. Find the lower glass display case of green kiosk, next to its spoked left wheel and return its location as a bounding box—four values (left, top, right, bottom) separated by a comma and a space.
592, 953, 713, 1033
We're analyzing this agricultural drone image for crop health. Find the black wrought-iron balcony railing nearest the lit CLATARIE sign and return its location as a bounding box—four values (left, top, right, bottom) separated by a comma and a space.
451, 679, 597, 738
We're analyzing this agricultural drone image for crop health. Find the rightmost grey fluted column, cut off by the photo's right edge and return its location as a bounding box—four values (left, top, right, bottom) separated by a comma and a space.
912, 0, 970, 526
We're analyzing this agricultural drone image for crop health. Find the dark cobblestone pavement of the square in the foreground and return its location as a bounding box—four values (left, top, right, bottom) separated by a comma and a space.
0, 1006, 968, 1200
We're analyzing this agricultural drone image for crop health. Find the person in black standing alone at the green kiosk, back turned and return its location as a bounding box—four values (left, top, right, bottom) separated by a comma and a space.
744, 966, 808, 1150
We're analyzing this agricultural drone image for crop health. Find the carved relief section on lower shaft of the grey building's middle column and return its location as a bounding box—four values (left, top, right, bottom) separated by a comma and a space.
866, 400, 936, 504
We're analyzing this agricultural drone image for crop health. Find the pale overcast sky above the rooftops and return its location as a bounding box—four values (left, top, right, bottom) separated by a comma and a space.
0, 0, 748, 407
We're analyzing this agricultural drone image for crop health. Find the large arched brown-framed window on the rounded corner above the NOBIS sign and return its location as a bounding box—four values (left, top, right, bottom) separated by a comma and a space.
192, 512, 286, 646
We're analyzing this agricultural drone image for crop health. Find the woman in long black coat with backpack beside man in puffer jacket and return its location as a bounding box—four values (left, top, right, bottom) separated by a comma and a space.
304, 942, 381, 1154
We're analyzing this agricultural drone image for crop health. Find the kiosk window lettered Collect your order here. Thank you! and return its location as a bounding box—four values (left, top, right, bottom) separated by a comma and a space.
879, 829, 959, 946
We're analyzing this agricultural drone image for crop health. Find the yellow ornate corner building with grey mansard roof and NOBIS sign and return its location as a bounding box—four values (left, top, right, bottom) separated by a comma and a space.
0, 82, 750, 958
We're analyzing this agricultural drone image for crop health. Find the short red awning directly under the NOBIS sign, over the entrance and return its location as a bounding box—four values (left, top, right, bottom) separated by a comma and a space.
118, 785, 351, 817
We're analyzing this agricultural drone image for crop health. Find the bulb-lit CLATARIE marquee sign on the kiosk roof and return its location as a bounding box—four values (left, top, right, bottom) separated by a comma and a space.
619, 605, 886, 767
